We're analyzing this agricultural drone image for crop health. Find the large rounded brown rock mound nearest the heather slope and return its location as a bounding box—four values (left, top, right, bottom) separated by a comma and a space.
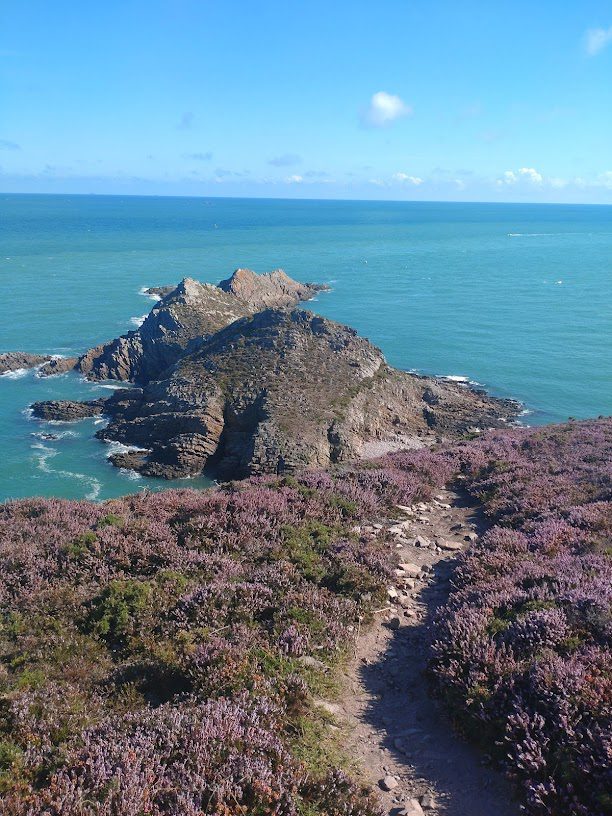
89, 309, 517, 478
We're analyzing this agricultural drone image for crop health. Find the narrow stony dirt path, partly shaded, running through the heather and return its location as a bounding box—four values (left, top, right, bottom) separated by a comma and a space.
322, 491, 519, 816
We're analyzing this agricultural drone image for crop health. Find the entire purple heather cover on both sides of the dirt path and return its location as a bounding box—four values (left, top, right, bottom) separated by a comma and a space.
0, 420, 612, 816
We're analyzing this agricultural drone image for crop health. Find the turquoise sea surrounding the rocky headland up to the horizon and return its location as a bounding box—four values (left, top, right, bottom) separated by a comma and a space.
0, 195, 612, 500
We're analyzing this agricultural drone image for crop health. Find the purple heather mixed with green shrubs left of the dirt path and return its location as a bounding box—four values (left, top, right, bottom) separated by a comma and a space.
0, 469, 427, 816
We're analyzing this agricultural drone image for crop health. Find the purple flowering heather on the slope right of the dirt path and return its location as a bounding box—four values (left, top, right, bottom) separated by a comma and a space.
420, 420, 612, 816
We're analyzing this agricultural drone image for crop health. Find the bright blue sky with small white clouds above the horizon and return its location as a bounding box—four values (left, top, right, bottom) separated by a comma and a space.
0, 0, 612, 203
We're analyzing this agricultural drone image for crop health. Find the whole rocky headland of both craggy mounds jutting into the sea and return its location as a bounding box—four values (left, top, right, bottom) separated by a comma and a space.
23, 269, 520, 479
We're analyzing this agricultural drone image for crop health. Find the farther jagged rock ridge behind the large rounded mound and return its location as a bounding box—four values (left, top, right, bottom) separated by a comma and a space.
76, 269, 326, 384
